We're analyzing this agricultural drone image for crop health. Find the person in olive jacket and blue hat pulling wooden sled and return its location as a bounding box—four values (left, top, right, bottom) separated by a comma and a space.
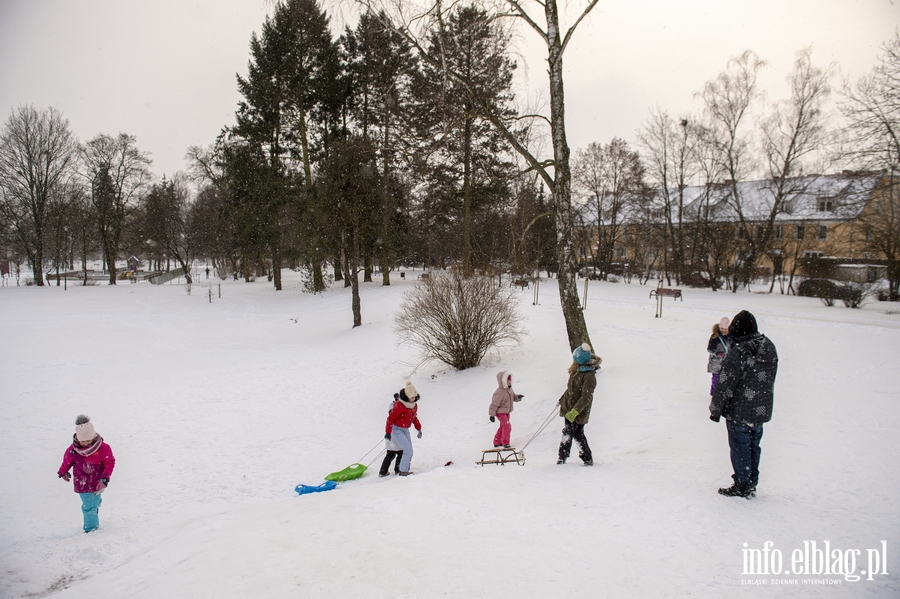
556, 343, 603, 466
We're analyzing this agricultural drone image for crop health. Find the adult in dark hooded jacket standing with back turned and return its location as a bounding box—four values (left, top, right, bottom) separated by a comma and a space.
709, 310, 778, 499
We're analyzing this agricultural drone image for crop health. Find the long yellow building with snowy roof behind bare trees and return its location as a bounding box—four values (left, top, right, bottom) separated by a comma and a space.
592, 171, 890, 279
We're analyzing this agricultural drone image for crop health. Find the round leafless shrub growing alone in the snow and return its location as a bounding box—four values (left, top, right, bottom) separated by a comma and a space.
394, 271, 524, 370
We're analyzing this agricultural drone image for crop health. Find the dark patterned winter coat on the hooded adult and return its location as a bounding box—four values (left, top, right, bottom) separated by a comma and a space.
709, 332, 778, 424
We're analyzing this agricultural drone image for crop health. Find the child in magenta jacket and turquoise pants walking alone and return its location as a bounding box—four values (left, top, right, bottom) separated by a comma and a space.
57, 415, 116, 532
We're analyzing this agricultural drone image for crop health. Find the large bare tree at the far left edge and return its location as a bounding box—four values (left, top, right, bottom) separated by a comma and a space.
0, 106, 78, 285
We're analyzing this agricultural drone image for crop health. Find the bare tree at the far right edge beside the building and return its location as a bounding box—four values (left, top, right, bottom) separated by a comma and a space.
841, 31, 900, 300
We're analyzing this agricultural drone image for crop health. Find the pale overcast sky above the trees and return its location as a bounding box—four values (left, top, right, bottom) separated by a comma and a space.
0, 0, 900, 176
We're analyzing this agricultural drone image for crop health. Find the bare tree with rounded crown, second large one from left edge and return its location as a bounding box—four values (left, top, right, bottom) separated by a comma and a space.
81, 133, 151, 285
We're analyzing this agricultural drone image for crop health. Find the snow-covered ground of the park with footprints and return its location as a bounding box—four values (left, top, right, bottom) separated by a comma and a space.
0, 271, 900, 599
